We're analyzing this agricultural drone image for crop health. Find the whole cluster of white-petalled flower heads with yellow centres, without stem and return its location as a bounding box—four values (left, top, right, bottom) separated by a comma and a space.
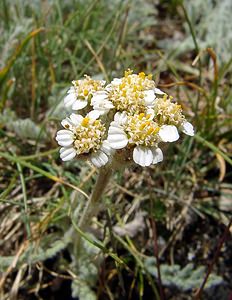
56, 70, 194, 167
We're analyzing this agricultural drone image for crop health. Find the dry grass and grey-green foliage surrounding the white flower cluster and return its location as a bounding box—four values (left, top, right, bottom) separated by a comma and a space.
0, 0, 232, 300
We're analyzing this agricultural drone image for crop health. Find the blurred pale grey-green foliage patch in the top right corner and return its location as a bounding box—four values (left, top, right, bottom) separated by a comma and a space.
161, 0, 232, 64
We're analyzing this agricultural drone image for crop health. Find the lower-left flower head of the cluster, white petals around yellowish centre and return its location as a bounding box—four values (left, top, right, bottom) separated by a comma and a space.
56, 111, 111, 167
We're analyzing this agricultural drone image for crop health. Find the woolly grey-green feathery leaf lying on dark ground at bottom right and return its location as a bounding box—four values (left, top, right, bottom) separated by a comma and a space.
144, 257, 223, 291
